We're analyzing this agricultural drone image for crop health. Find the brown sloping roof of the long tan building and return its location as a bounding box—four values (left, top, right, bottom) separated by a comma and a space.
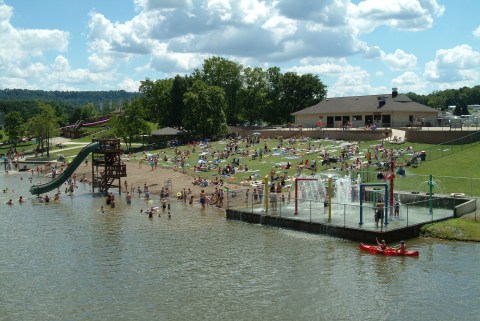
292, 94, 438, 116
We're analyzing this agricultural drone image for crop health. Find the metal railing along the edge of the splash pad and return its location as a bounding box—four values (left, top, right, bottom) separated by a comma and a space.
226, 190, 464, 231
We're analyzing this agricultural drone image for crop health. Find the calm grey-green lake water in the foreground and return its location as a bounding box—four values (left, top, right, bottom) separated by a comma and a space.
0, 174, 480, 320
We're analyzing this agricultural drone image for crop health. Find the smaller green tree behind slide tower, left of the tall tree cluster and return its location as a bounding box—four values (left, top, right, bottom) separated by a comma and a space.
110, 99, 150, 148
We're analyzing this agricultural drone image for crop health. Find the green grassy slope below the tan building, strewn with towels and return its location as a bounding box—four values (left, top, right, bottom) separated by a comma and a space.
136, 136, 480, 195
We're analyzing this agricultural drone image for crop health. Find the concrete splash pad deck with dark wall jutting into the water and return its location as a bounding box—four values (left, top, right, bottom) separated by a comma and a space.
226, 193, 468, 242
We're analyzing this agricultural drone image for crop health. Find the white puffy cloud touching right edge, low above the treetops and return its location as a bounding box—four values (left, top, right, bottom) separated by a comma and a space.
424, 44, 480, 87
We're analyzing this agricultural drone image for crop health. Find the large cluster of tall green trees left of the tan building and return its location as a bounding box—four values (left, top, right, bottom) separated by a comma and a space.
139, 57, 327, 137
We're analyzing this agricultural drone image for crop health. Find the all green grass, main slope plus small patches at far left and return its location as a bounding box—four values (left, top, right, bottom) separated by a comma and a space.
0, 124, 480, 195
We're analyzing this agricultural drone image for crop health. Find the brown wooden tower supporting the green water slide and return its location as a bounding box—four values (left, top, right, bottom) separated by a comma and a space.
92, 139, 127, 194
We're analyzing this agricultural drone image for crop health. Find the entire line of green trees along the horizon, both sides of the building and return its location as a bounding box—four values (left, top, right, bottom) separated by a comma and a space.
0, 57, 480, 147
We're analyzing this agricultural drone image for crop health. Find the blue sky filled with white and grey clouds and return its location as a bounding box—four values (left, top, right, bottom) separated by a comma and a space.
0, 0, 480, 97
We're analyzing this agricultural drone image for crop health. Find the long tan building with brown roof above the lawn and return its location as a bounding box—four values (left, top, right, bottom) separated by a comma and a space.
292, 88, 438, 128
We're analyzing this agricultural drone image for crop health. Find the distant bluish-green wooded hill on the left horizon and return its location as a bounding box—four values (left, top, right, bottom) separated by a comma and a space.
0, 89, 141, 106
